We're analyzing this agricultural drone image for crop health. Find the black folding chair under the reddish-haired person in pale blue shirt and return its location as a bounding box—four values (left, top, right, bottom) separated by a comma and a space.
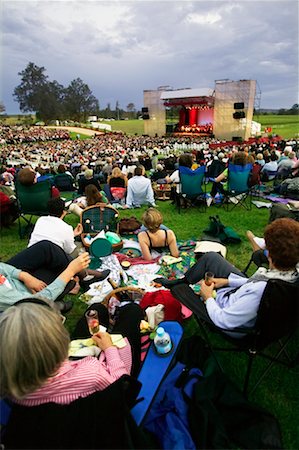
171, 280, 299, 395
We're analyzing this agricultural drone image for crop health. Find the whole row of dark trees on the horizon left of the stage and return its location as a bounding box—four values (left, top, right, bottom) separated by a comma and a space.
10, 62, 140, 123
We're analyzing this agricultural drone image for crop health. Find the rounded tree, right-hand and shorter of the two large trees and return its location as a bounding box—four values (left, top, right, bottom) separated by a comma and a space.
64, 78, 99, 121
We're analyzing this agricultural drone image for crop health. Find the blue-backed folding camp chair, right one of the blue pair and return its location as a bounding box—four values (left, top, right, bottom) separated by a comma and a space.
223, 164, 252, 211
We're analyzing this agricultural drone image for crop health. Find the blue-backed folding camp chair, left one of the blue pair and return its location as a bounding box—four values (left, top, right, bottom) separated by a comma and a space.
176, 166, 206, 213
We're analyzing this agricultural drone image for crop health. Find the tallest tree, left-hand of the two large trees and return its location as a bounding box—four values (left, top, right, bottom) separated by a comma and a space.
13, 62, 48, 113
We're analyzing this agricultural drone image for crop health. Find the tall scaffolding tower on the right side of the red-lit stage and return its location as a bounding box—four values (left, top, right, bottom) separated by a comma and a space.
213, 79, 256, 141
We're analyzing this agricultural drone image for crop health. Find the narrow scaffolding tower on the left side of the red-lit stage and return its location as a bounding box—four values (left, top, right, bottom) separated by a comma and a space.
143, 89, 166, 136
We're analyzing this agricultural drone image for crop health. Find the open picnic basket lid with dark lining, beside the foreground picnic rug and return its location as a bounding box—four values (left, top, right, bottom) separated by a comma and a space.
80, 203, 123, 251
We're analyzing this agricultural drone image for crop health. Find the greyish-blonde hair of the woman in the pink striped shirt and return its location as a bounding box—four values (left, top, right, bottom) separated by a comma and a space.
0, 299, 70, 399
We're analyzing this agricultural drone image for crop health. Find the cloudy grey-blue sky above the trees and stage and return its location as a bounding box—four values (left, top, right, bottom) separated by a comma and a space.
0, 0, 298, 114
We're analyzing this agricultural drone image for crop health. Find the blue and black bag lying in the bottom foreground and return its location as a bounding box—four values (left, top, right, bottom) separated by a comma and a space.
143, 336, 282, 450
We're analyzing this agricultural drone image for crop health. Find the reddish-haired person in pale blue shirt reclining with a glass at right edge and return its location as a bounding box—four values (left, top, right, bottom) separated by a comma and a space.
155, 218, 299, 335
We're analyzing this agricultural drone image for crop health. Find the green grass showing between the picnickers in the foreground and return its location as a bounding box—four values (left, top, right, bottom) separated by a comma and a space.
0, 201, 299, 449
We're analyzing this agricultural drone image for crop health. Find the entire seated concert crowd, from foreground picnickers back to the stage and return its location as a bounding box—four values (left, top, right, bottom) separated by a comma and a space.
0, 127, 299, 448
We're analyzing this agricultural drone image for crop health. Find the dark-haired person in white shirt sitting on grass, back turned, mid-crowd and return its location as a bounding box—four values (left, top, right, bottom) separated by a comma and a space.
126, 166, 156, 208
